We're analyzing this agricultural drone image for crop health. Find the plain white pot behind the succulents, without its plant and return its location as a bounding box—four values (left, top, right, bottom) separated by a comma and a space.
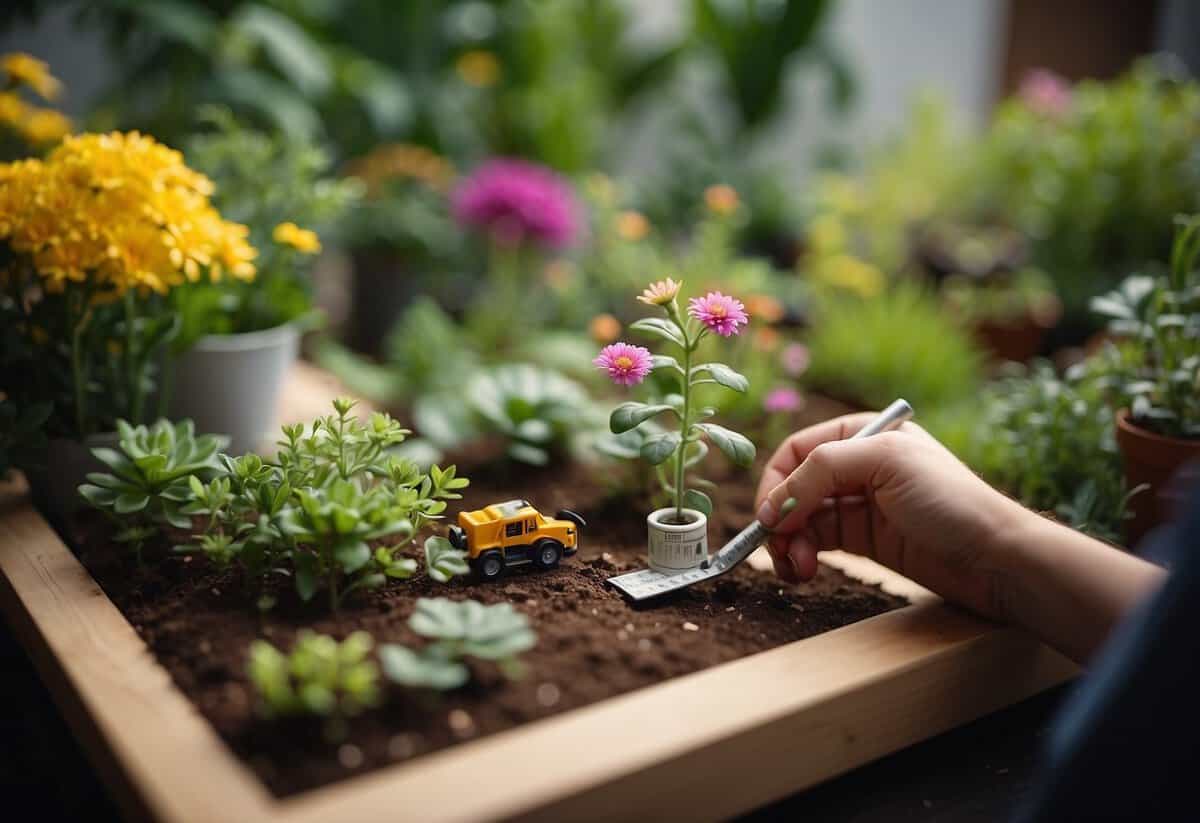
169, 324, 300, 453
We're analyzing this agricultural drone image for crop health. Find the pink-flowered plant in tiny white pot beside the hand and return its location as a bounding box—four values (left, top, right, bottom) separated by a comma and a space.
593, 277, 755, 572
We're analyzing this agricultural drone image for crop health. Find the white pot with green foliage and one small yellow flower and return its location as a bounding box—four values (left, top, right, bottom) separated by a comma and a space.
167, 109, 359, 451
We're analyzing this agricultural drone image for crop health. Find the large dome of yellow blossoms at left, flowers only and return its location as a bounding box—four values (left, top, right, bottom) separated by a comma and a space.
0, 132, 257, 296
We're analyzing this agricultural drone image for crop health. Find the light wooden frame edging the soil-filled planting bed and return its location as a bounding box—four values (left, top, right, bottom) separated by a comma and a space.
0, 371, 1076, 823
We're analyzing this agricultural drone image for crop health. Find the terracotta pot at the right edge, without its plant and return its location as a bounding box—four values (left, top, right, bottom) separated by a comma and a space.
1116, 409, 1200, 546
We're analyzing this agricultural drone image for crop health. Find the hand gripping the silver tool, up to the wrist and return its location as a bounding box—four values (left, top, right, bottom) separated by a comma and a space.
756, 413, 1038, 619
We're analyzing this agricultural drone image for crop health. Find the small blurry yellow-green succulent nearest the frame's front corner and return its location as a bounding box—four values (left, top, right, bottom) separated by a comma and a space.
247, 629, 382, 740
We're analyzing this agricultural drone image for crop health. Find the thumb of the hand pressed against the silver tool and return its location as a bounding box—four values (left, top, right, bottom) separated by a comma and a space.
758, 441, 896, 531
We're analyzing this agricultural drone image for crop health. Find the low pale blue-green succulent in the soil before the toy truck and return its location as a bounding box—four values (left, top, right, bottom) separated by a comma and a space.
379, 597, 538, 691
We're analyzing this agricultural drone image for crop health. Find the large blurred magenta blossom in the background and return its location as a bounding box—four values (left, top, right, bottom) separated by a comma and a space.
451, 157, 580, 248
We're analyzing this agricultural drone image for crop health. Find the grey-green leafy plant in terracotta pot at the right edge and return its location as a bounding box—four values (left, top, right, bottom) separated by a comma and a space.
1092, 215, 1200, 541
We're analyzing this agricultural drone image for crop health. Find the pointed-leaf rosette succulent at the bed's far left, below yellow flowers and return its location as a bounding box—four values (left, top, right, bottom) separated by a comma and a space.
79, 420, 227, 558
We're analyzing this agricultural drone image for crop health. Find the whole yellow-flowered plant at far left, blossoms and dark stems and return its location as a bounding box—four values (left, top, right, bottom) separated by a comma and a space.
0, 132, 254, 519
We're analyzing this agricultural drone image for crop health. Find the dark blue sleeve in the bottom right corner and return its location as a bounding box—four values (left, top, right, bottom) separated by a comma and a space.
1019, 494, 1200, 823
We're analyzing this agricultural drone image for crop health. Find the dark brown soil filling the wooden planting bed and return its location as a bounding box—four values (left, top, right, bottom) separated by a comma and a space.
70, 448, 905, 795
